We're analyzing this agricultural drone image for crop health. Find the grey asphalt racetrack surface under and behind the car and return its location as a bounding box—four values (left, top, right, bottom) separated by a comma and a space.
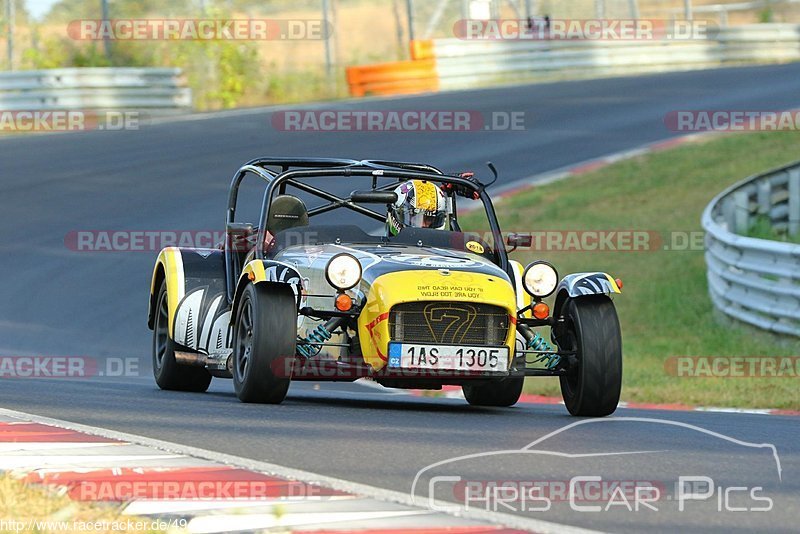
0, 65, 800, 532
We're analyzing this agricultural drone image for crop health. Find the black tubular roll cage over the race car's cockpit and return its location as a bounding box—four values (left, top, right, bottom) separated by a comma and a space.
224, 158, 513, 302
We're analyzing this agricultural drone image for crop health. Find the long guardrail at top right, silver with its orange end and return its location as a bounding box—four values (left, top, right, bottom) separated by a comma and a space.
347, 24, 800, 96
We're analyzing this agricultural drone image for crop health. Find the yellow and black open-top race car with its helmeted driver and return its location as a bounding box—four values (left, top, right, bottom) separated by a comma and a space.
148, 158, 622, 416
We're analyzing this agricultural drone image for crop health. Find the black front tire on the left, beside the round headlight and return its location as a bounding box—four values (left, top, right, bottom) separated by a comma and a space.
233, 284, 297, 404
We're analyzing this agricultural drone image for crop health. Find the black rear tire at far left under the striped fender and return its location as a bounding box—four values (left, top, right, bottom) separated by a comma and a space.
153, 282, 212, 393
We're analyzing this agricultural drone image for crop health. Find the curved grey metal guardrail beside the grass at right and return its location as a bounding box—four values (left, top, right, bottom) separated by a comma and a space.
703, 161, 800, 336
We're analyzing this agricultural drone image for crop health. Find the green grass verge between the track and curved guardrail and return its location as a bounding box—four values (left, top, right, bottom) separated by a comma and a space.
468, 133, 800, 409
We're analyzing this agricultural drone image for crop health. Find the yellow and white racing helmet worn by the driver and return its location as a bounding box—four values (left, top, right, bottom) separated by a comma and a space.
386, 180, 447, 236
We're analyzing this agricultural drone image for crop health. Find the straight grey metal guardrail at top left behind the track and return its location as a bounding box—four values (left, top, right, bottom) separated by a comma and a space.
0, 67, 192, 112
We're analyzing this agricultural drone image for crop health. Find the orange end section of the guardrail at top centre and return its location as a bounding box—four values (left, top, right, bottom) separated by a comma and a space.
347, 41, 439, 96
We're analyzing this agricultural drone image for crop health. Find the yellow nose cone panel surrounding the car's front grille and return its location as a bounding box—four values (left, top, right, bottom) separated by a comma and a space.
358, 270, 517, 371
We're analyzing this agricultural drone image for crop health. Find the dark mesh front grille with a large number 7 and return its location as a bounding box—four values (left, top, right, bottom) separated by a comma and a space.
389, 302, 509, 345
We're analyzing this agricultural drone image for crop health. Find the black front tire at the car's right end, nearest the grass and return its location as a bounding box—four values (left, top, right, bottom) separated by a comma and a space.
558, 295, 622, 417
